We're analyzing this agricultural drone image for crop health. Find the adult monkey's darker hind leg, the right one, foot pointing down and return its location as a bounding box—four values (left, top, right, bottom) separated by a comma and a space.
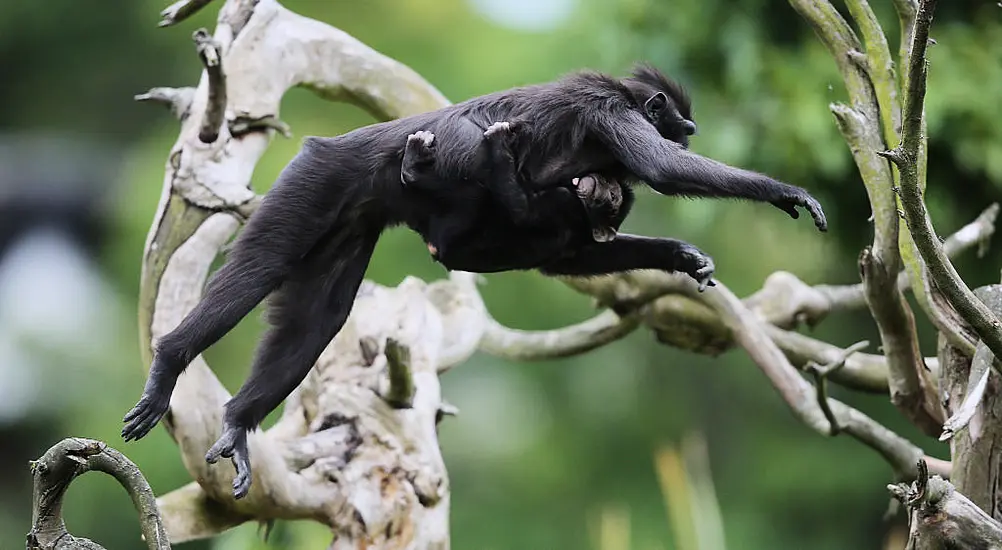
205, 227, 379, 499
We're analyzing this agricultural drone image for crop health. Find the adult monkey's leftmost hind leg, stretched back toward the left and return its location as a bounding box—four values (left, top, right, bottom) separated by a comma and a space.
122, 141, 348, 441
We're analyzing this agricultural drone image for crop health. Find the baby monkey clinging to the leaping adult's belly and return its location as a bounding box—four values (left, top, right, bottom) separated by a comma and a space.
400, 118, 629, 261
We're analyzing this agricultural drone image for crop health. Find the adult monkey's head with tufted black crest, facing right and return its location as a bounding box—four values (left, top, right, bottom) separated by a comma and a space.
622, 63, 695, 147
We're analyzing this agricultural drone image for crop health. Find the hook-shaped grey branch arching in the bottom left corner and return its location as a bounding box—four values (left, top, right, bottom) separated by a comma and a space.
27, 438, 170, 550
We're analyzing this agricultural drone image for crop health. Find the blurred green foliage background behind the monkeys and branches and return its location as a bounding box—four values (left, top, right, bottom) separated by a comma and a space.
0, 0, 1002, 550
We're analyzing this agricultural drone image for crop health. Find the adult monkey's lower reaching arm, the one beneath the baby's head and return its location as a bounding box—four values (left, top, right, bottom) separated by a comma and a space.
540, 234, 714, 292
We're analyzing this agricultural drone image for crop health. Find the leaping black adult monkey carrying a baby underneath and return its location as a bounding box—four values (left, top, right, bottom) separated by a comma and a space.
122, 61, 827, 498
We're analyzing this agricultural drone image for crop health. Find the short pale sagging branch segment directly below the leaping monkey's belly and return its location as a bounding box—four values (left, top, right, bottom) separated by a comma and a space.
480, 311, 640, 361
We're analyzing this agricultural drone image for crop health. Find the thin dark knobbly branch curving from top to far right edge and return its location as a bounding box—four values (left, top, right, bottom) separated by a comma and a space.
882, 0, 1002, 368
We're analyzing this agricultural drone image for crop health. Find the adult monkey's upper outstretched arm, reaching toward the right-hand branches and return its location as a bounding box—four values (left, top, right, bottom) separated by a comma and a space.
589, 109, 828, 231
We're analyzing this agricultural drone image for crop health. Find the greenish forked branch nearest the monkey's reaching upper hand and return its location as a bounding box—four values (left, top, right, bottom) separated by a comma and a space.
791, 0, 945, 435
